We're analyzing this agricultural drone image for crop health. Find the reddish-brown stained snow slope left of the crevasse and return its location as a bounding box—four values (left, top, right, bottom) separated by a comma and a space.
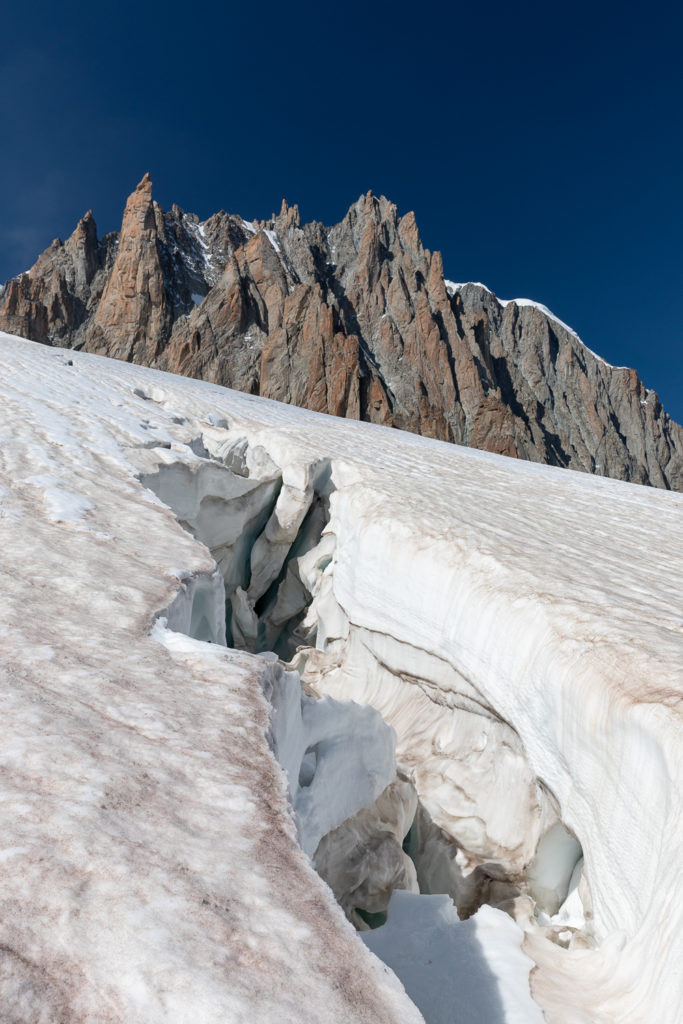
0, 337, 422, 1024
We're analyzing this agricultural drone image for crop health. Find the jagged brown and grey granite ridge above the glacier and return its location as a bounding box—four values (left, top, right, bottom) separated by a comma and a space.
0, 175, 683, 490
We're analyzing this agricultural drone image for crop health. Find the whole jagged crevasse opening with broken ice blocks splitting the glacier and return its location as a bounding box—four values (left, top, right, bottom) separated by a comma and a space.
139, 423, 593, 1024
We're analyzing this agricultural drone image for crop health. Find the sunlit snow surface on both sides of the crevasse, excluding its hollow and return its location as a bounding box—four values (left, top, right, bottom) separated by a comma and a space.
0, 336, 683, 1024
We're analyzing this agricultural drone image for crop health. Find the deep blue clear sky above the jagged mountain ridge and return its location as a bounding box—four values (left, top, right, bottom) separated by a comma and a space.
0, 0, 683, 422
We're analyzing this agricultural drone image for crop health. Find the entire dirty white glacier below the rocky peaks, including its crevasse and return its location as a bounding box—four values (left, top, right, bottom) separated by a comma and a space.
0, 335, 683, 1024
